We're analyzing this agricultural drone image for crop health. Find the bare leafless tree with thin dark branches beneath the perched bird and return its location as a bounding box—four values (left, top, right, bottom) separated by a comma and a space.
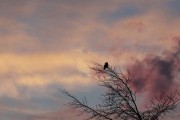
62, 63, 180, 120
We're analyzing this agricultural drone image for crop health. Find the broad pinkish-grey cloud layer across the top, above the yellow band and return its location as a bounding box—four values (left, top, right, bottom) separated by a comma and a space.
0, 0, 179, 54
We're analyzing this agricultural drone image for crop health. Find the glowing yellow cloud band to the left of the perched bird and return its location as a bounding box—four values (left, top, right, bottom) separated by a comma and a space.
0, 53, 93, 96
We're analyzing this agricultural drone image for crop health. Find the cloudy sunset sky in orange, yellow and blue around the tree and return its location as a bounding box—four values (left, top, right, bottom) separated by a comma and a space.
0, 0, 180, 120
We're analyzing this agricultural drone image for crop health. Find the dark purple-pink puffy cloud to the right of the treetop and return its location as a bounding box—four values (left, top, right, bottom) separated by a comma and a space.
128, 41, 180, 96
